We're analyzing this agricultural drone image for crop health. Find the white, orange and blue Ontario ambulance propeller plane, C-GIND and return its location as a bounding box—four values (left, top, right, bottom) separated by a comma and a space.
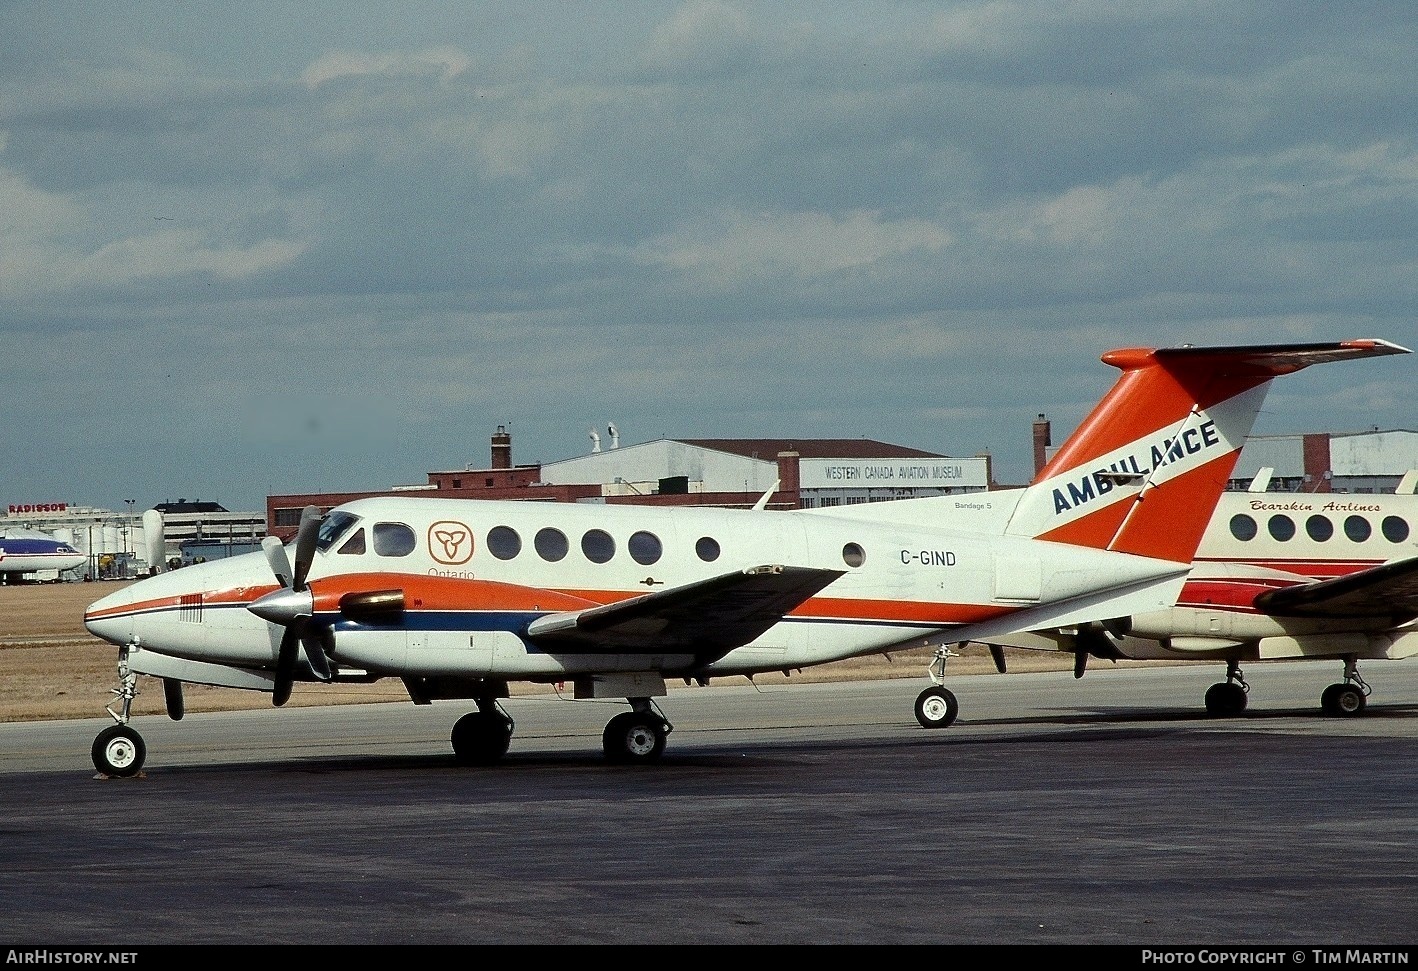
84, 339, 1408, 775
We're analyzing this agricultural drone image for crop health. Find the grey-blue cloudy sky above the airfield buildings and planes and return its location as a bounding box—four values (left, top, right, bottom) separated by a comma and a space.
0, 0, 1418, 510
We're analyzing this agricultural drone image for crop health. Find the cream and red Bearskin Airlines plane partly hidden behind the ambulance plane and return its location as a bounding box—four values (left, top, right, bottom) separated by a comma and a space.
916, 472, 1418, 727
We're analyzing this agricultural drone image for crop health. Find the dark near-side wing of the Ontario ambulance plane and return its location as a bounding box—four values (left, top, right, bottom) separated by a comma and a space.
526, 566, 844, 653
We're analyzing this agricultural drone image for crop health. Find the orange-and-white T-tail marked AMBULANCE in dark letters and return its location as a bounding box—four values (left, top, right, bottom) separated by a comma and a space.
1005, 340, 1409, 563
